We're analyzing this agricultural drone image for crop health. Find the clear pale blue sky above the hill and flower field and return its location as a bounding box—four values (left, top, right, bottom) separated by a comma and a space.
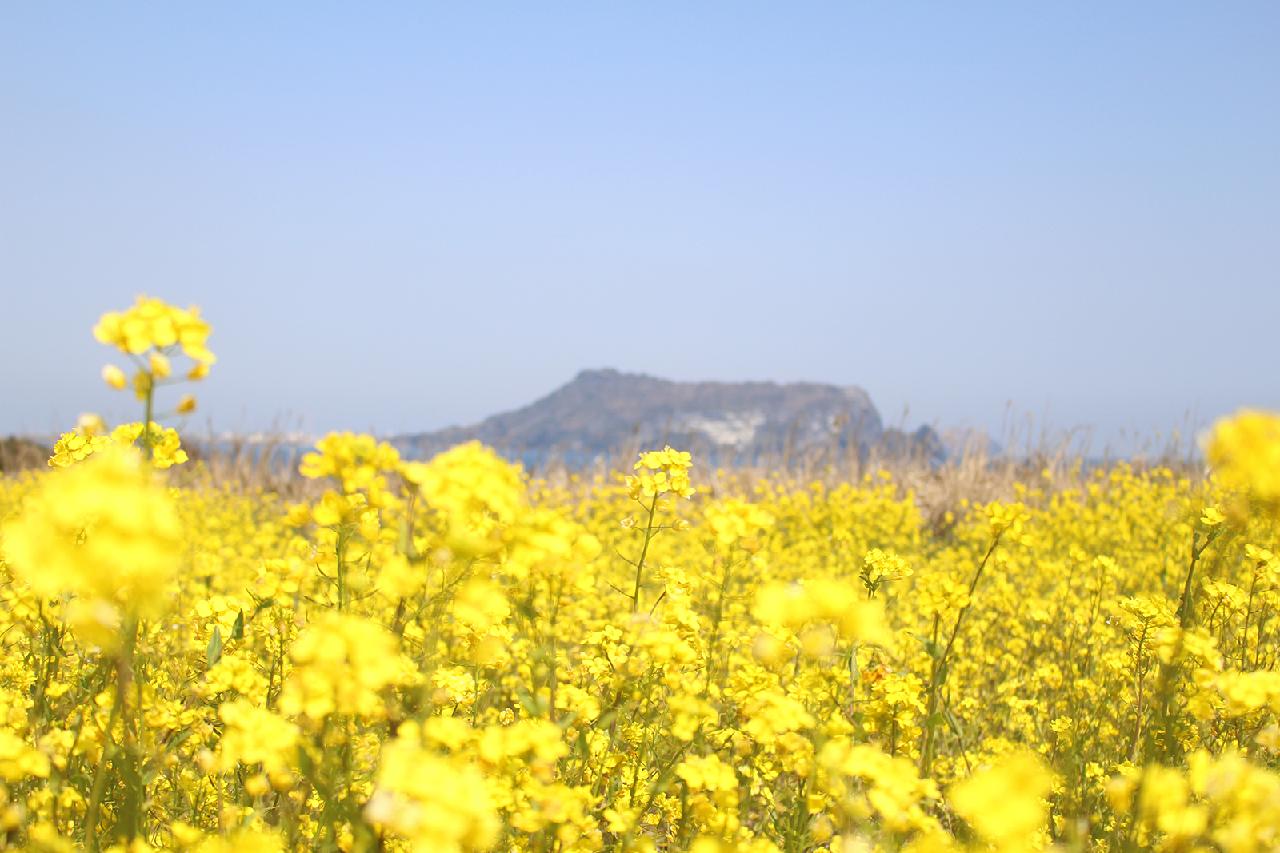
0, 3, 1280, 443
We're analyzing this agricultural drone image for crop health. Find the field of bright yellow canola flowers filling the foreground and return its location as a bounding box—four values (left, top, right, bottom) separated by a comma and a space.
0, 298, 1280, 853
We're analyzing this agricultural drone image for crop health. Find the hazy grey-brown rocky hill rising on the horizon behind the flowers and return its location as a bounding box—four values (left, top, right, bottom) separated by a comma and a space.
392, 369, 942, 462
